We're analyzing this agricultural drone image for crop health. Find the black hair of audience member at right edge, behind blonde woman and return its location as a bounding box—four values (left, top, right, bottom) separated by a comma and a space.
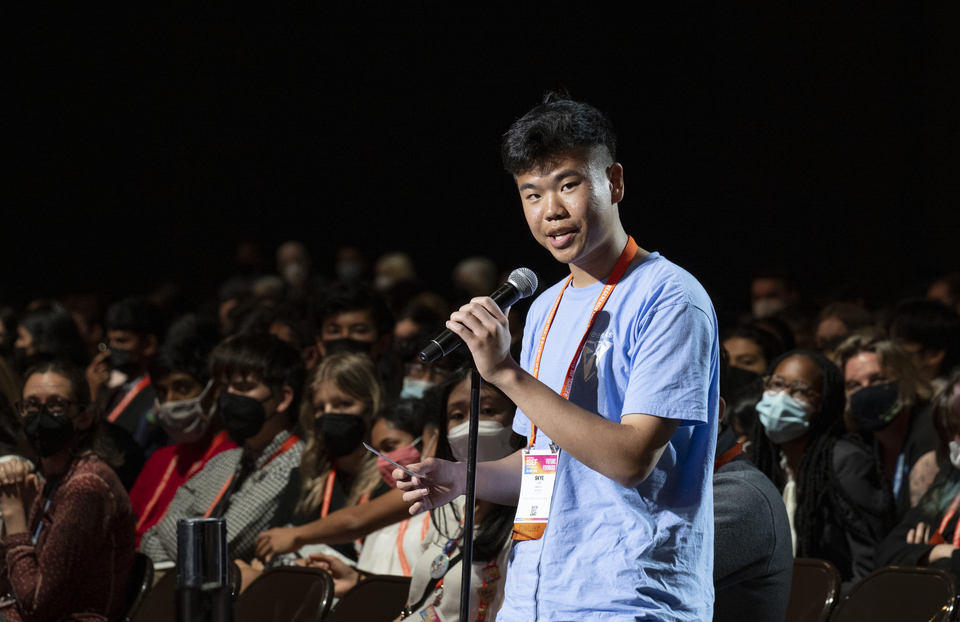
890, 298, 960, 375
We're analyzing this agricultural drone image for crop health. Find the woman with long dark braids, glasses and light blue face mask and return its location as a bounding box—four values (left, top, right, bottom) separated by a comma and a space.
749, 350, 895, 593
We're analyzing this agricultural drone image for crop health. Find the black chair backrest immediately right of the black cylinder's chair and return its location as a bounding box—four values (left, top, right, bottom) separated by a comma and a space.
237, 566, 333, 622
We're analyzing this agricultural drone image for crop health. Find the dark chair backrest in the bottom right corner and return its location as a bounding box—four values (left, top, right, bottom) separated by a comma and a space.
830, 566, 957, 622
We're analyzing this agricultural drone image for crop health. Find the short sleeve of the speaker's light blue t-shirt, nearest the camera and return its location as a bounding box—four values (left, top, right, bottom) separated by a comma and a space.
620, 302, 719, 425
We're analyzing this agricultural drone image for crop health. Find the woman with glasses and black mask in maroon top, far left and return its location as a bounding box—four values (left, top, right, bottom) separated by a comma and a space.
0, 361, 136, 622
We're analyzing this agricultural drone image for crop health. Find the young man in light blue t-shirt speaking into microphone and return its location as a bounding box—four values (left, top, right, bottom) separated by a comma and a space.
394, 95, 719, 622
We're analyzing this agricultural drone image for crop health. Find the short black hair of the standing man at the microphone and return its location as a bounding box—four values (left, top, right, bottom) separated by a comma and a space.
500, 91, 617, 177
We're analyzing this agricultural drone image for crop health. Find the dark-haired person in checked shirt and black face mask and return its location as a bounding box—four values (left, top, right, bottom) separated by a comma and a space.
140, 335, 305, 563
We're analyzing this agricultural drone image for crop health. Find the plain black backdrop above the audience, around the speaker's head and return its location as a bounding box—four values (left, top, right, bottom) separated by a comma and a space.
0, 1, 960, 324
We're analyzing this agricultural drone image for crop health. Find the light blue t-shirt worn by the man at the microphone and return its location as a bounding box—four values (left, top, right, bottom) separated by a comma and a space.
497, 253, 720, 622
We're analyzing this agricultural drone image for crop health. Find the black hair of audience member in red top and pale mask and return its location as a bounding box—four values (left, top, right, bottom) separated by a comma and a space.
149, 313, 220, 385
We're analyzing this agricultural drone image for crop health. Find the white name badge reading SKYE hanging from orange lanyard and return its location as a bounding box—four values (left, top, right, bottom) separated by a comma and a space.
513, 449, 560, 540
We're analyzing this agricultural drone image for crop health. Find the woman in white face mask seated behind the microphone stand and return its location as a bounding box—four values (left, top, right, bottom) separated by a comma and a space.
308, 369, 517, 622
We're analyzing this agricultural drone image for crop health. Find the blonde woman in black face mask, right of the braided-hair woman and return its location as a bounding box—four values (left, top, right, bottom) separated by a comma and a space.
835, 334, 938, 519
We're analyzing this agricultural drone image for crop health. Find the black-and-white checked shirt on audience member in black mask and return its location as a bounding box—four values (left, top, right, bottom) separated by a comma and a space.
140, 430, 303, 563
